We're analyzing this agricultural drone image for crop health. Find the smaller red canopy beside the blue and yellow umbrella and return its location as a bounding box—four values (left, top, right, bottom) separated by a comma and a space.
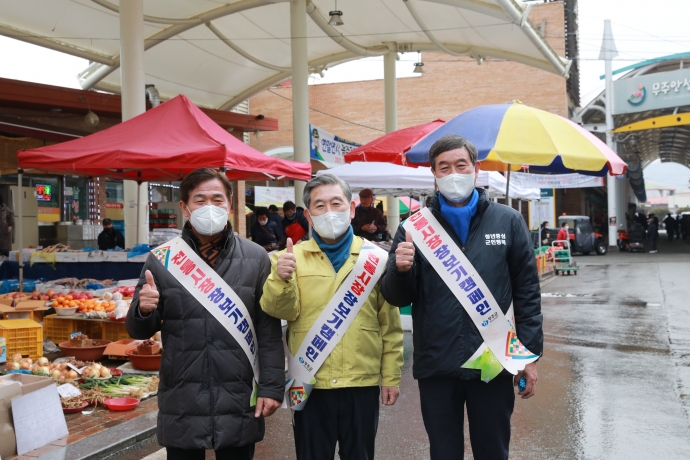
345, 120, 445, 167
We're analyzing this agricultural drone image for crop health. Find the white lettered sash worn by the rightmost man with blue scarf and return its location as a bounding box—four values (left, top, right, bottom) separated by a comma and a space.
403, 208, 539, 382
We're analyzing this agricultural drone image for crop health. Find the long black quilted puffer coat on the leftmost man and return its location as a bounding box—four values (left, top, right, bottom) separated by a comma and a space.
126, 230, 285, 450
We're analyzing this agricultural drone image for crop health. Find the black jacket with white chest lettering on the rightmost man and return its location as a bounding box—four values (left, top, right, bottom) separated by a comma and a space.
381, 189, 544, 380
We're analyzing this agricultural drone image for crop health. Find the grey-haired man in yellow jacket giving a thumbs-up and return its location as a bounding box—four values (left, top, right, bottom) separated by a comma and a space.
261, 174, 403, 460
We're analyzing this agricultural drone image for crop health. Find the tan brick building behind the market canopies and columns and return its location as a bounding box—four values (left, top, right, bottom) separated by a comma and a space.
249, 0, 586, 222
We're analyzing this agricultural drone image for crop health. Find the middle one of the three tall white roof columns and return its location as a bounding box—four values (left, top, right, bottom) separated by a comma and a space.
290, 0, 310, 206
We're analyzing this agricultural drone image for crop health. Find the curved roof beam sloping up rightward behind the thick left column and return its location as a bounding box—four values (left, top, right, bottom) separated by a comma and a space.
79, 0, 289, 89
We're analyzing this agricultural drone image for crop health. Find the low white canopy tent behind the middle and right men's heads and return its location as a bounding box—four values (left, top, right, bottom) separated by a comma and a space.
316, 161, 540, 200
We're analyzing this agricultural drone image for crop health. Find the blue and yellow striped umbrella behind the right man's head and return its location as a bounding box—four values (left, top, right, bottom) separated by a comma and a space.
407, 102, 626, 176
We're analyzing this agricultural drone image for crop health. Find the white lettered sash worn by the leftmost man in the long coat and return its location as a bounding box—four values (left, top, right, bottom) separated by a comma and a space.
151, 237, 259, 406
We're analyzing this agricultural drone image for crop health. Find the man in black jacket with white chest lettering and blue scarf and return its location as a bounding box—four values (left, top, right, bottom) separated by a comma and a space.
381, 136, 543, 460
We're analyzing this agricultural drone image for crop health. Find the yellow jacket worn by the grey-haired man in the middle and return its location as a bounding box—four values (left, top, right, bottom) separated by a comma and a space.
261, 236, 403, 389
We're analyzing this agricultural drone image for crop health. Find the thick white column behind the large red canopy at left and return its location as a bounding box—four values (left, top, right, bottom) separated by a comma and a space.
120, 0, 149, 248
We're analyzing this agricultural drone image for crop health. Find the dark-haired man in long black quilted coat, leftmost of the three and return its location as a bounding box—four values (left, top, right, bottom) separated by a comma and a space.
125, 168, 285, 460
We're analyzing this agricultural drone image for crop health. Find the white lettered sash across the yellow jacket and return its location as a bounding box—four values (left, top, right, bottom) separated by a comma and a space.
285, 240, 388, 410
